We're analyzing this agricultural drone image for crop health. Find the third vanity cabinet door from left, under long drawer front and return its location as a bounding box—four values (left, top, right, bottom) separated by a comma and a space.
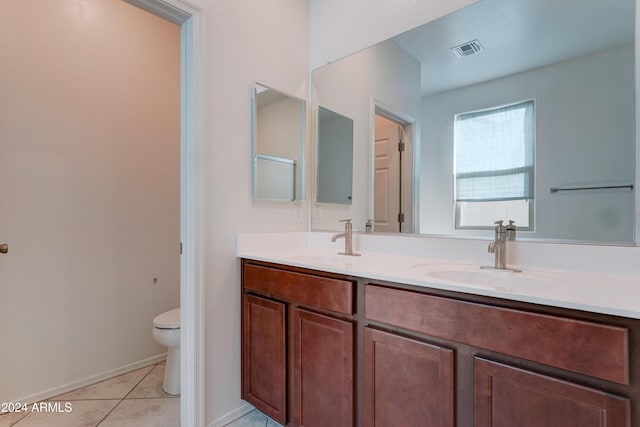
364, 328, 455, 427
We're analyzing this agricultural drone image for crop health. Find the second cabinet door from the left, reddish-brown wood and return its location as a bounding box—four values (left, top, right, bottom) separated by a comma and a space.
292, 308, 353, 427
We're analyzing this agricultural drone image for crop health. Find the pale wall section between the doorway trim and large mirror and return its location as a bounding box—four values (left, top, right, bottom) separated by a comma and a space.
192, 0, 310, 425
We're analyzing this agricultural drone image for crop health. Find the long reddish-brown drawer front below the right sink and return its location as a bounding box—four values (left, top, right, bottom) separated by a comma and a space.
365, 285, 629, 384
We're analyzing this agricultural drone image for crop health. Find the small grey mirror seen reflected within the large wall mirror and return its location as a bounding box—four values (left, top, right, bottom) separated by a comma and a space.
316, 107, 353, 205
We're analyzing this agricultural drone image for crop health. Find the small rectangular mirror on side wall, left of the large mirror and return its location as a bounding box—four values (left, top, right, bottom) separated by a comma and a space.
252, 84, 305, 201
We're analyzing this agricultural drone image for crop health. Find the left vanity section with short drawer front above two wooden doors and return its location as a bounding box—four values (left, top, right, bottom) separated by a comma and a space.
242, 261, 355, 427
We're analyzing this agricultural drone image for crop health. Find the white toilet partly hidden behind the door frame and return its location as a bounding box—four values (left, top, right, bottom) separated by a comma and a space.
153, 308, 180, 395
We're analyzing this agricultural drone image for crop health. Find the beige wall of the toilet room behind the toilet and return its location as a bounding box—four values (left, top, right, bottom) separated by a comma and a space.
0, 0, 180, 401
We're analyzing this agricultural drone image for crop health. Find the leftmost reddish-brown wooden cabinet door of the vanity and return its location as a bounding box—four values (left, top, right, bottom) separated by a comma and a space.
242, 294, 287, 424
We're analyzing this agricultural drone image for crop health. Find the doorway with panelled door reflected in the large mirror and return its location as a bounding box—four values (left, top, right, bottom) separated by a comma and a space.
373, 107, 414, 233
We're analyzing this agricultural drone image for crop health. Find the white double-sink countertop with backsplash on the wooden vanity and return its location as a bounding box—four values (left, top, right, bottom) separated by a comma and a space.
237, 232, 640, 319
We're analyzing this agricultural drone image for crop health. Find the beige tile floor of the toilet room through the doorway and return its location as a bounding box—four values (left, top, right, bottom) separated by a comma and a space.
0, 362, 178, 427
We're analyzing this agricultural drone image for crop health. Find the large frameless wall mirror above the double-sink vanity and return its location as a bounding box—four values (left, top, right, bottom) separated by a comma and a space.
312, 0, 636, 245
